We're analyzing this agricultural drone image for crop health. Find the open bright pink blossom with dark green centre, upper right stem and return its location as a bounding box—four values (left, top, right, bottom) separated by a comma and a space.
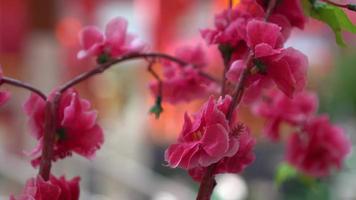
226, 20, 308, 99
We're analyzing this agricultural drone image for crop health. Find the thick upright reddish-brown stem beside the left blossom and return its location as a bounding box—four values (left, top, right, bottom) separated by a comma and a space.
38, 92, 61, 181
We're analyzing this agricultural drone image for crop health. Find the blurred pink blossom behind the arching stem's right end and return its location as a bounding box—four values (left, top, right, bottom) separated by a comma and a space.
150, 45, 216, 104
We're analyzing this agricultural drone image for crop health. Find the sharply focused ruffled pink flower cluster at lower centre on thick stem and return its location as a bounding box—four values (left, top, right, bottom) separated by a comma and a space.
165, 95, 255, 180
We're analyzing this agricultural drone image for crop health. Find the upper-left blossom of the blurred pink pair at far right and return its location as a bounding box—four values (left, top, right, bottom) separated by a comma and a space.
253, 90, 318, 141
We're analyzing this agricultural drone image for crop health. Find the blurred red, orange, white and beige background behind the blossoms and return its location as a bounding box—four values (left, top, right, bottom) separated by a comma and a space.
0, 0, 356, 200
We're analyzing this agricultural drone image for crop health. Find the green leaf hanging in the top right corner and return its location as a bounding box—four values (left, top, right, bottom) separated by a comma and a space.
302, 0, 356, 47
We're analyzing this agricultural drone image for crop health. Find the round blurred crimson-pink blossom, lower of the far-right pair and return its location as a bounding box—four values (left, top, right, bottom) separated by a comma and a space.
286, 116, 351, 177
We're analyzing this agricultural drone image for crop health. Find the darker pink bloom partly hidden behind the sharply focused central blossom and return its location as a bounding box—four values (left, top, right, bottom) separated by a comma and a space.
189, 126, 256, 182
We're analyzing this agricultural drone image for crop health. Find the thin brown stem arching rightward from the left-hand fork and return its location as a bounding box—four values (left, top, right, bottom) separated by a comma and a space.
58, 53, 217, 93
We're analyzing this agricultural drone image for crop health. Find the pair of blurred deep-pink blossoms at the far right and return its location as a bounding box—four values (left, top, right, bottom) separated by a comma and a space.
254, 90, 351, 177
